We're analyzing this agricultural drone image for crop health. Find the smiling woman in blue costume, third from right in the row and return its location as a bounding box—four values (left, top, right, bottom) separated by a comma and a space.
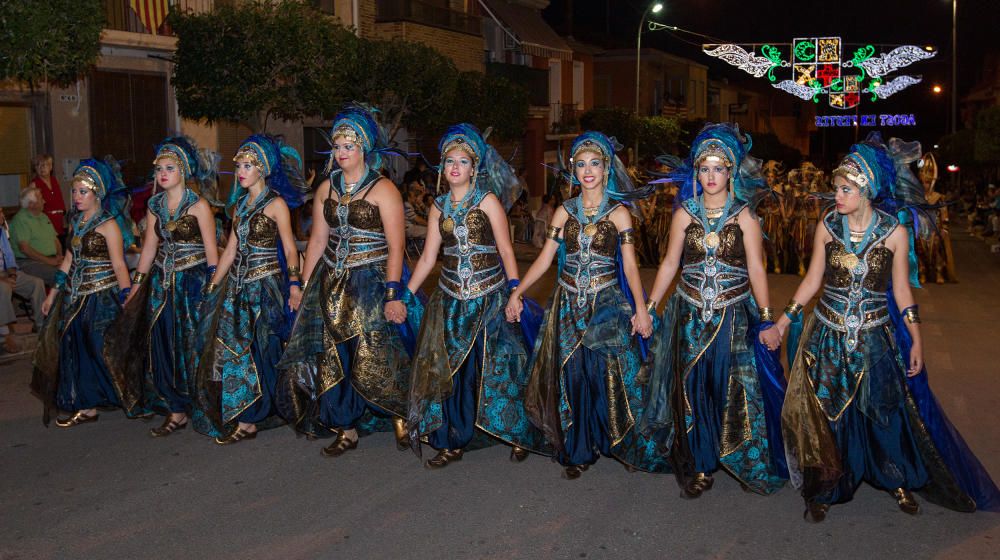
506, 132, 668, 480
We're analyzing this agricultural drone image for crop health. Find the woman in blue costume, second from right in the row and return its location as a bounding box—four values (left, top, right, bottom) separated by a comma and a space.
641, 124, 787, 498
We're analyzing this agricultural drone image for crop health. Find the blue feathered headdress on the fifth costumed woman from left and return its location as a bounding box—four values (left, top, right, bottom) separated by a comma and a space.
438, 123, 524, 211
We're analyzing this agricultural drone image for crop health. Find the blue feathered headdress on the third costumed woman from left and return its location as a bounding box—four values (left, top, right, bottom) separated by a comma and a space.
226, 134, 308, 208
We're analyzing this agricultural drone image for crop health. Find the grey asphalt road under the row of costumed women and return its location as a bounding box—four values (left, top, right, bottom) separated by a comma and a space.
0, 233, 1000, 560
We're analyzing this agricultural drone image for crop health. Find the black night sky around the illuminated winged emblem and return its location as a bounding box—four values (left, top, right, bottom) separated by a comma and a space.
544, 0, 1000, 150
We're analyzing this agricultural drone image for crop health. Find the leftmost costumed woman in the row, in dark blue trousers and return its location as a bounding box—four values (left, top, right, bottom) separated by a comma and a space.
31, 156, 132, 428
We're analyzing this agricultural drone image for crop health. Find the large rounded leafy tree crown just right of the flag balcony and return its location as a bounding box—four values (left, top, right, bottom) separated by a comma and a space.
169, 0, 356, 130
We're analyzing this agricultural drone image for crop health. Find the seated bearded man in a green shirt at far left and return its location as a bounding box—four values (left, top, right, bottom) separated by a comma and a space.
10, 187, 62, 286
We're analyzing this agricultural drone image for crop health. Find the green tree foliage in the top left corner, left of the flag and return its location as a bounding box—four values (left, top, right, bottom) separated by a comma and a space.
0, 0, 104, 89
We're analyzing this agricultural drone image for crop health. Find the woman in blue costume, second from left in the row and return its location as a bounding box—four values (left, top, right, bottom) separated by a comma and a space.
104, 136, 219, 437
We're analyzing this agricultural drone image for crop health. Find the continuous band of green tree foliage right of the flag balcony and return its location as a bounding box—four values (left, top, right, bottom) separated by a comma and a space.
170, 0, 528, 138
